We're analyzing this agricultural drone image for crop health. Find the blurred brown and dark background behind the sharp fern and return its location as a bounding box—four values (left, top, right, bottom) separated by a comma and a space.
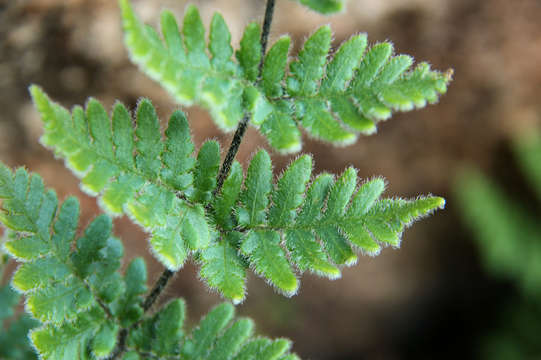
0, 0, 541, 360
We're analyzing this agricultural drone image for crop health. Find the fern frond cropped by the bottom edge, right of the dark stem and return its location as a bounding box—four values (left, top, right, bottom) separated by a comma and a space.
128, 299, 299, 360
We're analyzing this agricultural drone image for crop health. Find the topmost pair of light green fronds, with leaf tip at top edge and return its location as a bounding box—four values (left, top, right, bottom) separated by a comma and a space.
120, 0, 450, 152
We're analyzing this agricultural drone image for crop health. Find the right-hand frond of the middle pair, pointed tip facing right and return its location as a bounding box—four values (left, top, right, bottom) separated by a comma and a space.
199, 150, 444, 302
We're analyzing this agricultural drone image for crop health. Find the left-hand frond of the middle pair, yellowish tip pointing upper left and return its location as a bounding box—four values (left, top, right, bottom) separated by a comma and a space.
30, 86, 212, 270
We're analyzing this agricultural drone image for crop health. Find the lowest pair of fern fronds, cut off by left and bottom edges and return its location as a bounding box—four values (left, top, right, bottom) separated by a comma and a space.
0, 163, 297, 359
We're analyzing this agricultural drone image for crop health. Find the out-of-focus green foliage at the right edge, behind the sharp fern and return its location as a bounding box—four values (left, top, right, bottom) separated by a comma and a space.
456, 132, 541, 360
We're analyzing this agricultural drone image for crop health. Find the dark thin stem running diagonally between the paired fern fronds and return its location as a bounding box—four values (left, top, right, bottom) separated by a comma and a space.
110, 0, 276, 359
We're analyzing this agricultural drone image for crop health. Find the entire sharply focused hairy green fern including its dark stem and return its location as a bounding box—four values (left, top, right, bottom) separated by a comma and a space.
0, 0, 450, 360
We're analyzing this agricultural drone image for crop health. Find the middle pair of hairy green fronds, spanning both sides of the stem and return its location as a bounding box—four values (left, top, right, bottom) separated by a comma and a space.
31, 87, 444, 302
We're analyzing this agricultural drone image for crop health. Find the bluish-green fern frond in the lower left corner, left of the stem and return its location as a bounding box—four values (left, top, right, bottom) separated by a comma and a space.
0, 163, 146, 359
